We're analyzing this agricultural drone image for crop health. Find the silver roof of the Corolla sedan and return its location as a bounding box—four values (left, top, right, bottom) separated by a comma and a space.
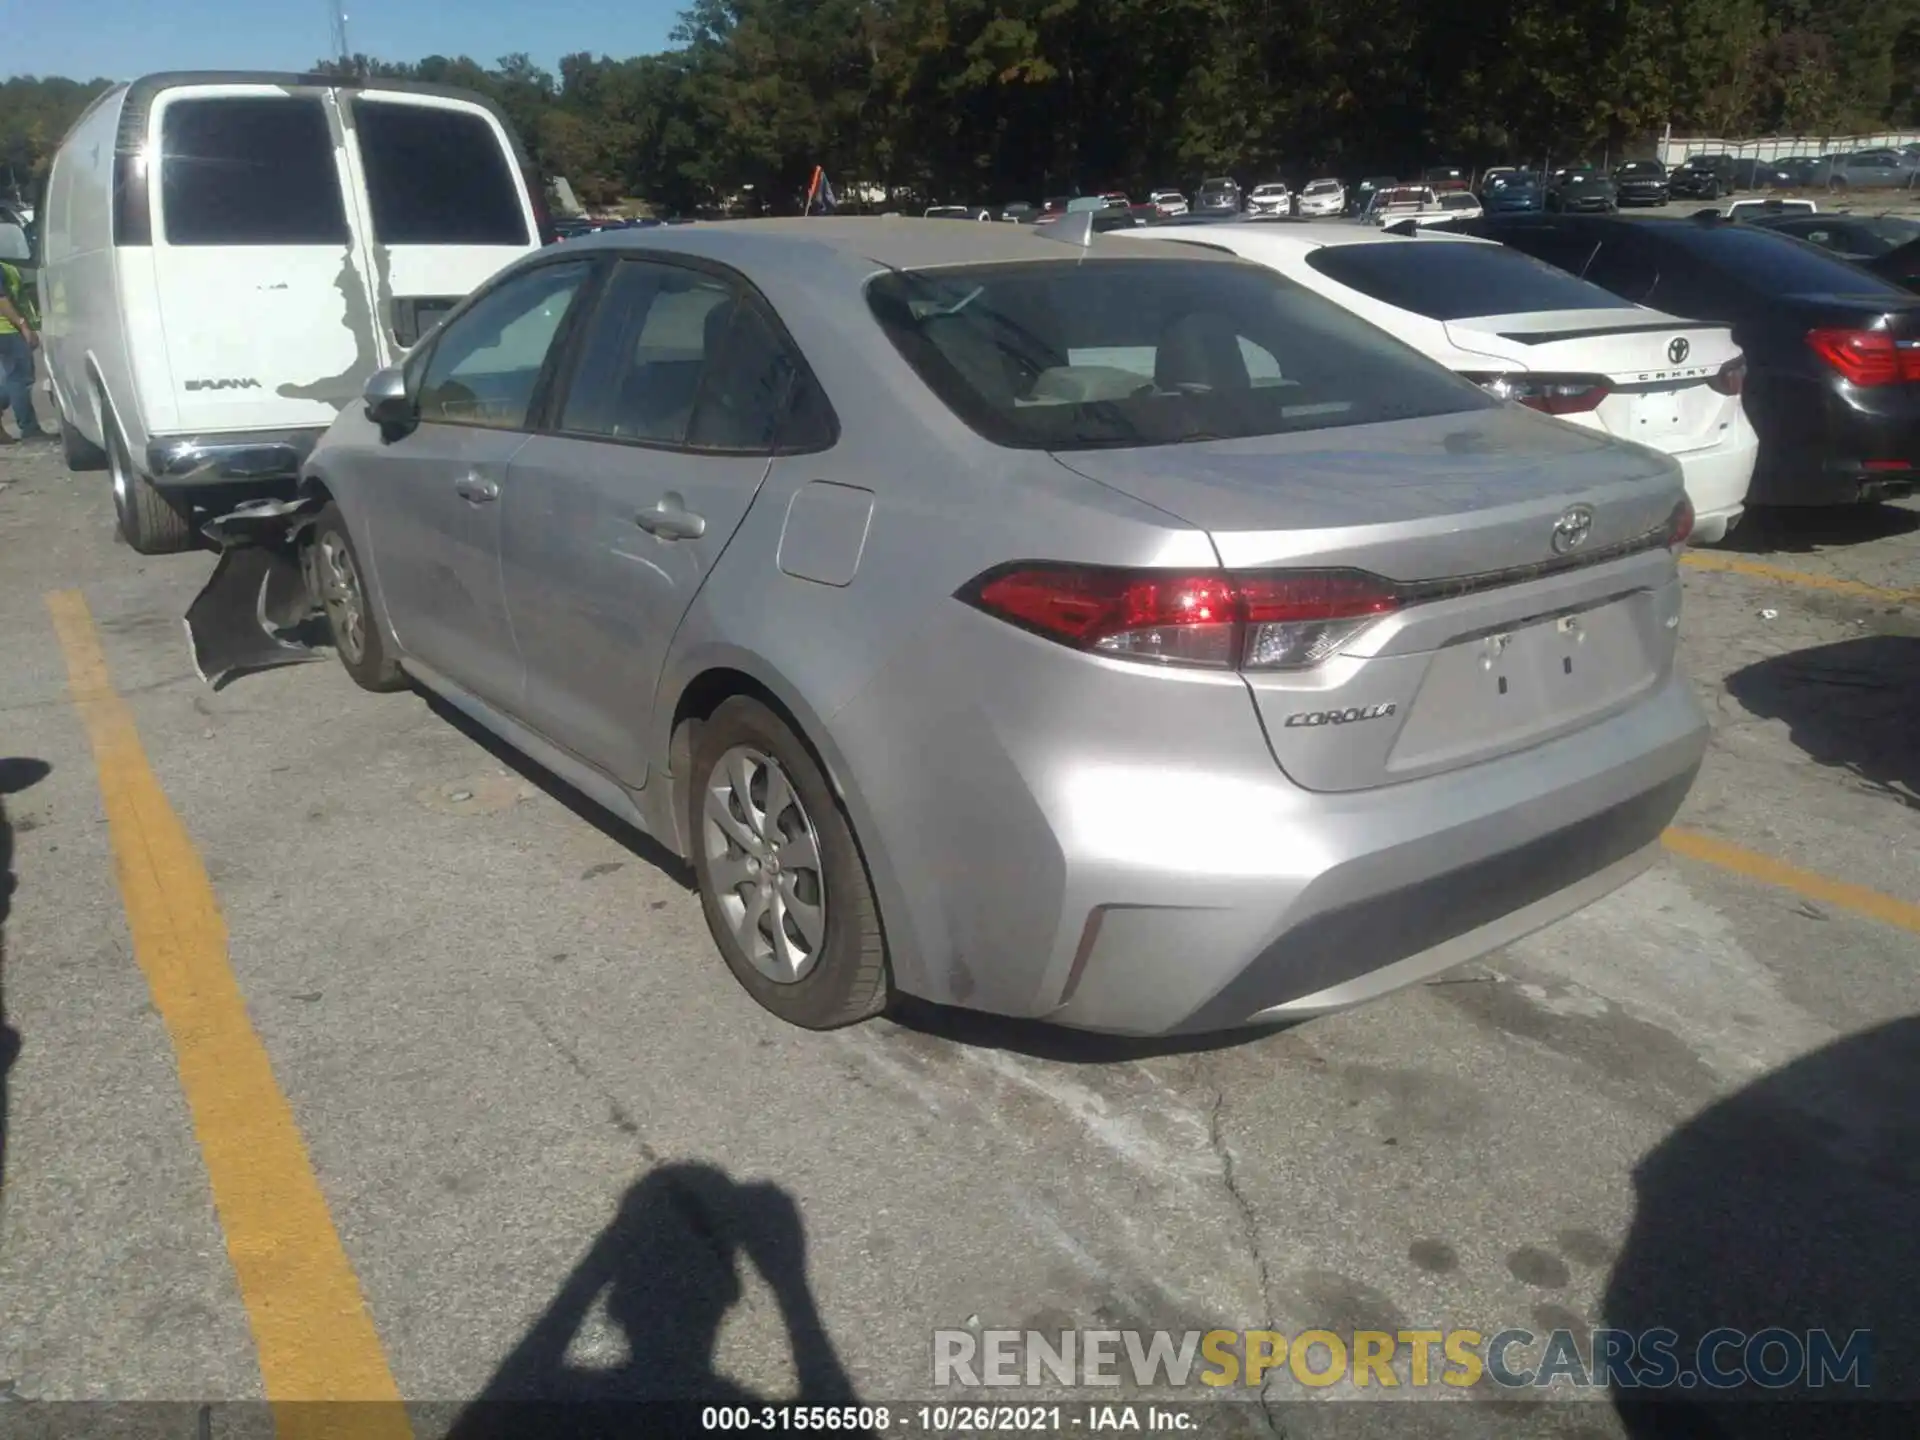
568, 211, 1236, 271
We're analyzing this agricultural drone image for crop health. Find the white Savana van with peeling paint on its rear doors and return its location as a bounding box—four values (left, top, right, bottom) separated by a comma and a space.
40, 71, 551, 555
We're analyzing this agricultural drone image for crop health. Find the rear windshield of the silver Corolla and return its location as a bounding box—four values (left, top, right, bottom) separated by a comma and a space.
868, 259, 1498, 449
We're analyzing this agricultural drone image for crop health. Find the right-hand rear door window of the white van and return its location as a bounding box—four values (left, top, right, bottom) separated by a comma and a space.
353, 96, 530, 246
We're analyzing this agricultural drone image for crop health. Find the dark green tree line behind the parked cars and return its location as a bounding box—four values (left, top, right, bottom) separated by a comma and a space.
0, 0, 1920, 211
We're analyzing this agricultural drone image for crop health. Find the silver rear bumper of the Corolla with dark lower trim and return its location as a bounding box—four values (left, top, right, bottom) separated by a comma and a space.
831, 599, 1707, 1035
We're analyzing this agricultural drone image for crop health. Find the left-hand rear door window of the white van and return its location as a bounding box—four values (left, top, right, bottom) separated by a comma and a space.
159, 96, 348, 246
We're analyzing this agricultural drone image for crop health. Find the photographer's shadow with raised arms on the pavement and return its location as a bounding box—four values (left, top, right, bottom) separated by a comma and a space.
447, 1164, 856, 1440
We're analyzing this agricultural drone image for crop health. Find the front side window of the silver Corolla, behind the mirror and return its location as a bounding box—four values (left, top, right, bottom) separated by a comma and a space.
408, 261, 593, 430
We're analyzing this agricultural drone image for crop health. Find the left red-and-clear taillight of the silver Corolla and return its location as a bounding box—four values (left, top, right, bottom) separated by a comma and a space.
960, 563, 1402, 670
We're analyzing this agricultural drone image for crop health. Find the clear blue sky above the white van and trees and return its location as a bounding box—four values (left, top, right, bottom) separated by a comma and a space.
15, 0, 684, 79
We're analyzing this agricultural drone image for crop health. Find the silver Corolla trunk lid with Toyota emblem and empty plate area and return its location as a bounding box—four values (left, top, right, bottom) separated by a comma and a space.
1056, 409, 1682, 791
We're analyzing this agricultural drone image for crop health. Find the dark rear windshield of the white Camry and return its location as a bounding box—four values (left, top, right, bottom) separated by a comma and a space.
1308, 238, 1634, 321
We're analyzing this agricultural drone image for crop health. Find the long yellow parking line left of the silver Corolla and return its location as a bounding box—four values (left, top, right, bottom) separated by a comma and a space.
46, 589, 413, 1440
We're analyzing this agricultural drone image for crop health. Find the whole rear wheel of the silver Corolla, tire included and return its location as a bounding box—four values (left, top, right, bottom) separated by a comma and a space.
687, 695, 891, 1029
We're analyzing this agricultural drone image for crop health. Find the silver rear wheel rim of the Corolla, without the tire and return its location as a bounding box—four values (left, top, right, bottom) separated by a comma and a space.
701, 745, 828, 985
